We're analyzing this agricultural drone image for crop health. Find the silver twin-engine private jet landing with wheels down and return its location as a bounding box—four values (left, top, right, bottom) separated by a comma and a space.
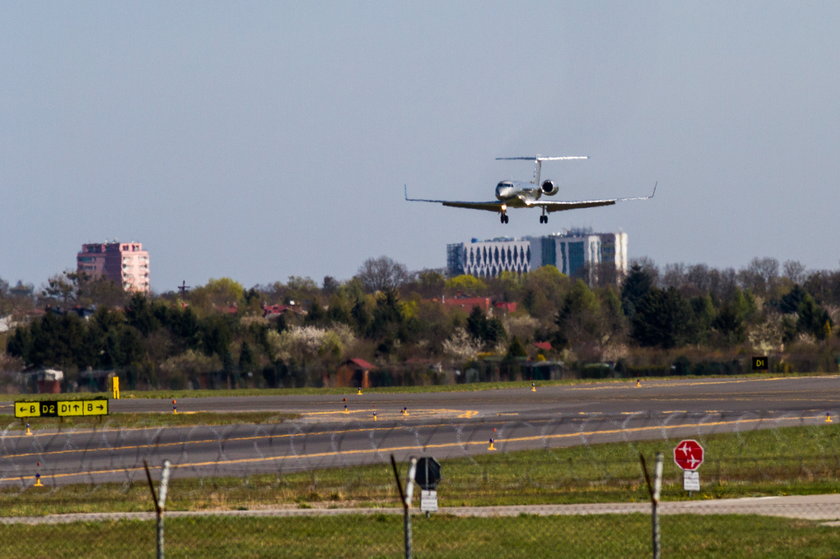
403, 155, 658, 223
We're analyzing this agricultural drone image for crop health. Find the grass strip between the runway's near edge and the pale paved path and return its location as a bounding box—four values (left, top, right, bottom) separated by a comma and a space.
0, 423, 840, 516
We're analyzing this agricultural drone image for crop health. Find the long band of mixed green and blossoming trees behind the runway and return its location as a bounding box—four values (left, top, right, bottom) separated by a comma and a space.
0, 257, 840, 388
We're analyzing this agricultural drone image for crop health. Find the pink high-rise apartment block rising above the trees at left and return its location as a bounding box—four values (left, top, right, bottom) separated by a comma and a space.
76, 243, 150, 293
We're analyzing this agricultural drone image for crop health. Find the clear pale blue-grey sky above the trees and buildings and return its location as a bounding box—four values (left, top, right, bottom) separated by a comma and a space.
0, 0, 840, 292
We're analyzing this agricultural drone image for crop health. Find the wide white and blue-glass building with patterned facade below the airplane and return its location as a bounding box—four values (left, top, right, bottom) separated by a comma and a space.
446, 229, 628, 284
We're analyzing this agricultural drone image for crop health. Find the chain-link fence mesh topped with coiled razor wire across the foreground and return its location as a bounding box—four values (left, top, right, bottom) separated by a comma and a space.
0, 413, 840, 559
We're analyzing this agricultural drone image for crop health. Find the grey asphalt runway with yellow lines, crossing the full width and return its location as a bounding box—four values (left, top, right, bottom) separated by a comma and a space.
0, 376, 840, 487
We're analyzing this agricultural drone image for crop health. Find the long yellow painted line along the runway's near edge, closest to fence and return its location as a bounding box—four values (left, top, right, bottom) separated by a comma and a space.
0, 415, 824, 483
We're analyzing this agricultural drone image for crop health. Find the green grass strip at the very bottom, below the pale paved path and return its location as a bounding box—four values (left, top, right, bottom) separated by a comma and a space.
0, 514, 840, 559
